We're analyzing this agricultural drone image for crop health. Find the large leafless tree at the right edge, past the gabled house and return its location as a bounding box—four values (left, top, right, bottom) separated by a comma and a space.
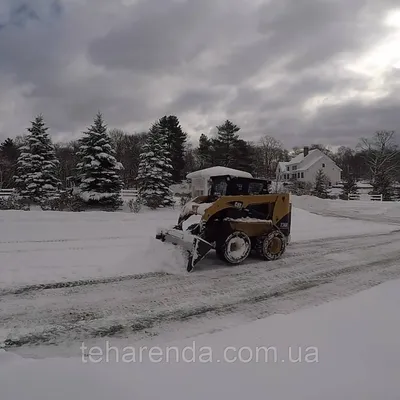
359, 131, 400, 200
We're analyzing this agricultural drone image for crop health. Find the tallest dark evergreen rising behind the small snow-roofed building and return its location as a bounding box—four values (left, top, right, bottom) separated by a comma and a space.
214, 120, 240, 168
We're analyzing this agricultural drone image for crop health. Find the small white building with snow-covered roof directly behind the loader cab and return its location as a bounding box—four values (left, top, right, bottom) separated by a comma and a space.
186, 167, 252, 198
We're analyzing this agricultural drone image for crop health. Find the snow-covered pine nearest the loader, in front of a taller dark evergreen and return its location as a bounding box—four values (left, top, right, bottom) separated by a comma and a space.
137, 122, 174, 208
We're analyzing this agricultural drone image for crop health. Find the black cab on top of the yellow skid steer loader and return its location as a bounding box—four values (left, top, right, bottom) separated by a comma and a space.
209, 175, 271, 198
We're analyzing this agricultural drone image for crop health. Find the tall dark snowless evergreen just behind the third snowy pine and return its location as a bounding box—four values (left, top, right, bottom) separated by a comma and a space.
159, 115, 187, 183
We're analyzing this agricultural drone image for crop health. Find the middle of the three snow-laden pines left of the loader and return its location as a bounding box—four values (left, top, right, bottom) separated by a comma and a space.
77, 112, 123, 209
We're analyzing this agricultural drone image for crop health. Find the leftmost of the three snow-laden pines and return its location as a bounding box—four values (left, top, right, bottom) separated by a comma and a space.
15, 115, 61, 204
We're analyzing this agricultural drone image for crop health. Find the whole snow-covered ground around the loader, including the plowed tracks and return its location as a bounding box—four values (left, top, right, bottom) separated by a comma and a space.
0, 196, 400, 400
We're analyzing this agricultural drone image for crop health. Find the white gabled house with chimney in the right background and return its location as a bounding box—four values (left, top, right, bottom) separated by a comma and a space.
276, 147, 342, 185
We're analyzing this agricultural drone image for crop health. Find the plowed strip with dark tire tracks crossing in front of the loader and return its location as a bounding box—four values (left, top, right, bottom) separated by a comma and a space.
0, 234, 400, 347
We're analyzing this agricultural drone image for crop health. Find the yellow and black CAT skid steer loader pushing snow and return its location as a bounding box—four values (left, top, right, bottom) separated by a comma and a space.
156, 175, 292, 272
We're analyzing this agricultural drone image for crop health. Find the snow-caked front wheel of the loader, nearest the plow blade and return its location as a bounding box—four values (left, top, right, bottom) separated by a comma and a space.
216, 231, 251, 265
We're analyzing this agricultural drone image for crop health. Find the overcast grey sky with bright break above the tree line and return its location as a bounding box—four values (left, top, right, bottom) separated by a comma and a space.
0, 0, 400, 147
